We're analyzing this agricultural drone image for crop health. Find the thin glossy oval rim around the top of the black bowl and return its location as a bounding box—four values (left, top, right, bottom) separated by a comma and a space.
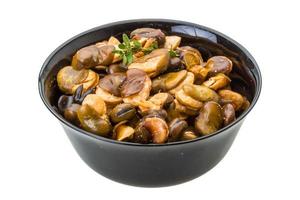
38, 18, 262, 147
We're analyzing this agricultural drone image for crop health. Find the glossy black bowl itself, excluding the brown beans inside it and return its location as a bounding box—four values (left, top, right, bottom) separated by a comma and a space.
39, 19, 261, 187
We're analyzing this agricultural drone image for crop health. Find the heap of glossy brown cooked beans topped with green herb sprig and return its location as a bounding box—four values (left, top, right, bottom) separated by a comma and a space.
57, 28, 250, 144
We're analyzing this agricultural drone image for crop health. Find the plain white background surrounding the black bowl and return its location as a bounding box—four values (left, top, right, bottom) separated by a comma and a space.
0, 0, 300, 200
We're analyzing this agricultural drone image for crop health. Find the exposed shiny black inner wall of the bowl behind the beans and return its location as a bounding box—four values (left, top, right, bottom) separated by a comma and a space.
39, 20, 261, 141
